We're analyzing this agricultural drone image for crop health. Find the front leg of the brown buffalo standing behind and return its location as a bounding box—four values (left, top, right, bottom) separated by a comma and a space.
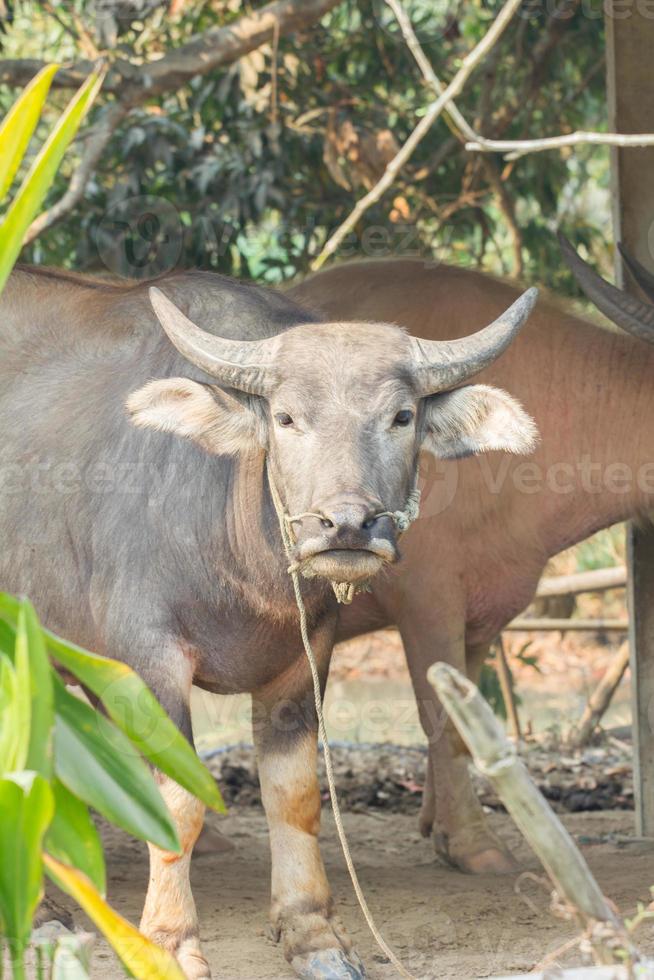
400, 612, 516, 874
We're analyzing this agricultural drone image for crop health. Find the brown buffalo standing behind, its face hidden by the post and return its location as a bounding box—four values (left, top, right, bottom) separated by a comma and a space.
289, 244, 654, 872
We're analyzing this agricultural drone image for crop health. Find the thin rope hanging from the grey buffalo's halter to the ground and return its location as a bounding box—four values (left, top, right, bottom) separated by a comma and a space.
267, 467, 420, 980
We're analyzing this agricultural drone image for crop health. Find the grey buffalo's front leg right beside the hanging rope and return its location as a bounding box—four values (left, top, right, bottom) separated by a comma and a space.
254, 668, 364, 980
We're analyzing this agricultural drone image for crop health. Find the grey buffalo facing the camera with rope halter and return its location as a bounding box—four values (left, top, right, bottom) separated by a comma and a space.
0, 269, 535, 978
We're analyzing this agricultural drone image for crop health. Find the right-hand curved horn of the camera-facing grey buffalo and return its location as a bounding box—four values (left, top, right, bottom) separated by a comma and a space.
413, 286, 538, 395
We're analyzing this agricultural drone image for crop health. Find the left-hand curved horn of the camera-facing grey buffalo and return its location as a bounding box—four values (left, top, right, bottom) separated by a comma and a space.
149, 286, 278, 395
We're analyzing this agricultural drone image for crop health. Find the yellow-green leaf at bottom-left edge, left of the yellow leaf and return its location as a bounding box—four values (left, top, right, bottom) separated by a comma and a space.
0, 771, 54, 963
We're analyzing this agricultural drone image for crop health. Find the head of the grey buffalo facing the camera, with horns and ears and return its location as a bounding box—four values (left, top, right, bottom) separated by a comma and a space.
128, 288, 537, 582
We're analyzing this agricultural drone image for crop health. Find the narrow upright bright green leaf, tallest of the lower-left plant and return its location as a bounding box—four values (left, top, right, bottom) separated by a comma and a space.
16, 599, 54, 779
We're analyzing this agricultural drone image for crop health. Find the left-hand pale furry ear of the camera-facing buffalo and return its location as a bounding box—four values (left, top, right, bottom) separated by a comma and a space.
126, 378, 265, 456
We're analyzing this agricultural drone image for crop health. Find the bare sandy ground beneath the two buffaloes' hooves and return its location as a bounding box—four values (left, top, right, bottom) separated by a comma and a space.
50, 807, 654, 980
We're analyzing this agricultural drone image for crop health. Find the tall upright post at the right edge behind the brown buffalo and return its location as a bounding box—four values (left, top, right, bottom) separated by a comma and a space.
605, 0, 654, 837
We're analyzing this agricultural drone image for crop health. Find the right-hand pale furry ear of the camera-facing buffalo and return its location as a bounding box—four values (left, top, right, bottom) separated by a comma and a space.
422, 385, 538, 459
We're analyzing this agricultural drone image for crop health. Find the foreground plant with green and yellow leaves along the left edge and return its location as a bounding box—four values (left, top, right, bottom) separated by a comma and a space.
0, 65, 223, 980
